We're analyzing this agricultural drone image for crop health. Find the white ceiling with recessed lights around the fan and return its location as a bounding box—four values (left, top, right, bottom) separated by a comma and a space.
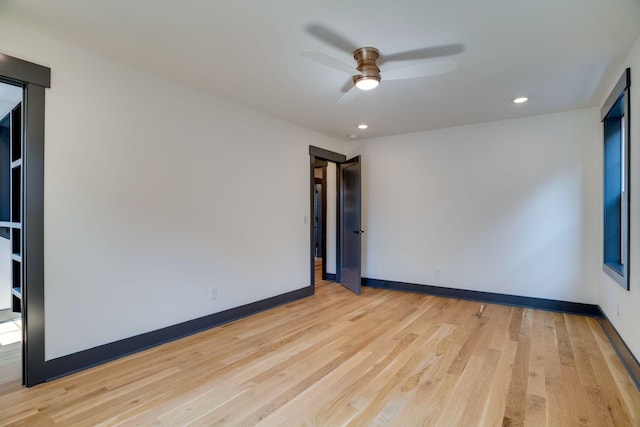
0, 0, 640, 139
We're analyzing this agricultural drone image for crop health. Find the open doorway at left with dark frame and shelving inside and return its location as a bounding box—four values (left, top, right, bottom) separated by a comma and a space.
0, 53, 51, 386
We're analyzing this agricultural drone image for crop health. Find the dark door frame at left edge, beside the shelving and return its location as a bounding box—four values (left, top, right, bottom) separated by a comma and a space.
0, 53, 51, 387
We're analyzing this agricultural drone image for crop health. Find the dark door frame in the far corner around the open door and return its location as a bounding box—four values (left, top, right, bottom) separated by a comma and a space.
309, 145, 347, 292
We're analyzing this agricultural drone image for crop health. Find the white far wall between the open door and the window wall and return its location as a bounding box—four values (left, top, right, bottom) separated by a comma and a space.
349, 109, 601, 304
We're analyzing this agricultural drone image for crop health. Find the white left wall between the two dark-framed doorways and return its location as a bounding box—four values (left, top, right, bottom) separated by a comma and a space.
0, 21, 342, 360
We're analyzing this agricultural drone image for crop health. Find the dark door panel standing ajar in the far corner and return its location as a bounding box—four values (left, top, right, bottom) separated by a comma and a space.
340, 156, 363, 295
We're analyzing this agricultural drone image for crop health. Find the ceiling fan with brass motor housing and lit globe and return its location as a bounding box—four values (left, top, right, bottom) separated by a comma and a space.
301, 24, 464, 105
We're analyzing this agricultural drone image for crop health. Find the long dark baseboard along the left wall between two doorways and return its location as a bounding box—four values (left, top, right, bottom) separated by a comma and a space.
45, 286, 314, 381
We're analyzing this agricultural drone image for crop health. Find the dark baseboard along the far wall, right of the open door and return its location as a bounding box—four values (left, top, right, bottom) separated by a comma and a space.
362, 278, 602, 317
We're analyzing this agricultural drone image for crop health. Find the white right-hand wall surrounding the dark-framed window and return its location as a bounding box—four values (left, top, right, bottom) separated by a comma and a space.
599, 34, 640, 359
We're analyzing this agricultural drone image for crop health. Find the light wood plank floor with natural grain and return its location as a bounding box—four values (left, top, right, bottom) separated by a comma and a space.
0, 283, 640, 427
